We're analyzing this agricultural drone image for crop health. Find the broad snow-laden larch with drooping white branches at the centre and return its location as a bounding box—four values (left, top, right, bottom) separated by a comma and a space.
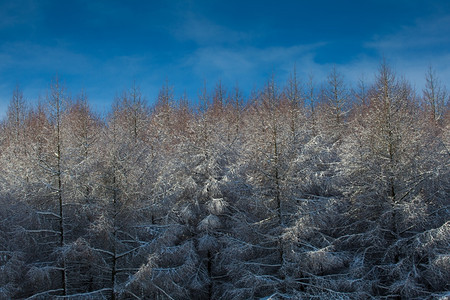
128, 81, 234, 298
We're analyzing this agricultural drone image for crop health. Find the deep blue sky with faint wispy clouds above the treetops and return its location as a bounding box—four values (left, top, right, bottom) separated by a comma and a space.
0, 0, 450, 116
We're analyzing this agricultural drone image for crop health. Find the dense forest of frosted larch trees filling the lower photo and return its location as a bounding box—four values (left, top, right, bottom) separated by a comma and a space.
0, 63, 450, 299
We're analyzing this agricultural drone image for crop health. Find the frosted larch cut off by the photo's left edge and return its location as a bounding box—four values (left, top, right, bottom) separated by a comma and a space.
0, 86, 31, 299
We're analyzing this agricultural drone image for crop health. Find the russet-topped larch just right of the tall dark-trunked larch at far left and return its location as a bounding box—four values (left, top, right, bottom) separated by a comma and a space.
59, 92, 104, 297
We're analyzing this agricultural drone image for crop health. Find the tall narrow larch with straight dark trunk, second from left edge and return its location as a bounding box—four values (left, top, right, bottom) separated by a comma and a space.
14, 78, 69, 296
